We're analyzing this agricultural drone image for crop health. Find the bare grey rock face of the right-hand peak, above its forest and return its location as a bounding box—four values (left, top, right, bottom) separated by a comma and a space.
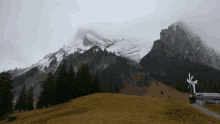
152, 22, 220, 69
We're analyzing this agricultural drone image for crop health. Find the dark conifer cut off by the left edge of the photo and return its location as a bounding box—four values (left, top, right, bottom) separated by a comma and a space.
0, 72, 14, 118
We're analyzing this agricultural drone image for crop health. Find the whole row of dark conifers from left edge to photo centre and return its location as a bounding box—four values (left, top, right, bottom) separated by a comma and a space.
0, 50, 123, 118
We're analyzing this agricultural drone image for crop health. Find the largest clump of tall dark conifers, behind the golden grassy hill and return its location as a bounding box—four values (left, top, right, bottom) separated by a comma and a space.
37, 54, 100, 108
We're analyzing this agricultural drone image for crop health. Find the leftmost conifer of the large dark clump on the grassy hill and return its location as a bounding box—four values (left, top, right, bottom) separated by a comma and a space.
37, 71, 56, 108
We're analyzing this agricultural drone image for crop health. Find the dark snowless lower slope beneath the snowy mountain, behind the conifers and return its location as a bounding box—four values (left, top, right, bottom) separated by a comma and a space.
13, 46, 148, 102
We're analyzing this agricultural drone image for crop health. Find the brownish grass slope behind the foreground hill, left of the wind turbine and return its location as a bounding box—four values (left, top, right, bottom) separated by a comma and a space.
121, 75, 192, 103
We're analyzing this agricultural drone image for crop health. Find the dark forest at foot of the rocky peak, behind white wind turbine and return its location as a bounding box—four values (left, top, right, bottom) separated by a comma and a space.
150, 54, 220, 93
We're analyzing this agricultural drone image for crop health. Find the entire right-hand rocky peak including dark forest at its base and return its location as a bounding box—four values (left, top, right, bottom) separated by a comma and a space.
140, 22, 220, 92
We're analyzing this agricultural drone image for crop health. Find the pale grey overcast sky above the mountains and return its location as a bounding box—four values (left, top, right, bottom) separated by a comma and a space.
0, 0, 220, 72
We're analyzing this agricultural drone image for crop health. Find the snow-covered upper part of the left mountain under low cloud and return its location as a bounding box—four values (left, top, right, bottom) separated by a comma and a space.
7, 28, 153, 77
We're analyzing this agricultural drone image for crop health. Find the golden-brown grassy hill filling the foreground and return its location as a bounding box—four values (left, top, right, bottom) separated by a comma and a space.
0, 93, 220, 124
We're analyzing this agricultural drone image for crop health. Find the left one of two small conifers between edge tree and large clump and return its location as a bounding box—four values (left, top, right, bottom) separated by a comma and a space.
15, 84, 27, 112
